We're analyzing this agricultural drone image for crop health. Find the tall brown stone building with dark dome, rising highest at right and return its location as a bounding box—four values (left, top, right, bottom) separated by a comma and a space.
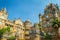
39, 3, 60, 40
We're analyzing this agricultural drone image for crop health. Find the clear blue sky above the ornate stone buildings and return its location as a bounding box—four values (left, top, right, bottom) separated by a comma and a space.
0, 0, 60, 24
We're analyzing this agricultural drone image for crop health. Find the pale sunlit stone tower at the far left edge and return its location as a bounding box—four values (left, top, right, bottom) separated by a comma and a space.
0, 8, 8, 28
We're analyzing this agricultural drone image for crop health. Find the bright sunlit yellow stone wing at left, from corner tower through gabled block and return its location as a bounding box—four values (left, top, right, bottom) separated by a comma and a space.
0, 8, 25, 40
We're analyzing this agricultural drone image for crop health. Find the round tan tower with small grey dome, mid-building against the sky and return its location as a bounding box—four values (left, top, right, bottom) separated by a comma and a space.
24, 19, 32, 40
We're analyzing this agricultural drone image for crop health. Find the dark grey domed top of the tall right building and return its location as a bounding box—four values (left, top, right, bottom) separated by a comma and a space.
44, 3, 59, 14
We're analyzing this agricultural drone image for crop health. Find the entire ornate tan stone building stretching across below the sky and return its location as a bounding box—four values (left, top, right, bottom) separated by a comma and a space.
0, 3, 60, 40
